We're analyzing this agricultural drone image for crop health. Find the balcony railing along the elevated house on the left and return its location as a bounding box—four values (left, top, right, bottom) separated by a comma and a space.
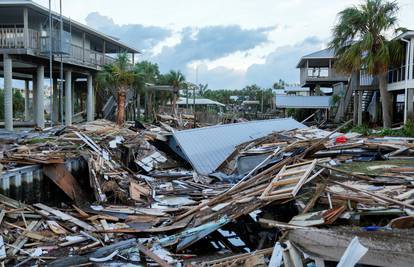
0, 27, 114, 67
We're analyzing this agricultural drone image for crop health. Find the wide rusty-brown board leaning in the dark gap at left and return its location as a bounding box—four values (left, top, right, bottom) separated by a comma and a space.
43, 163, 86, 202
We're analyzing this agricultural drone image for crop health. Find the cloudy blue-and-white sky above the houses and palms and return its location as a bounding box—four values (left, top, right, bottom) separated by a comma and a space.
31, 0, 414, 89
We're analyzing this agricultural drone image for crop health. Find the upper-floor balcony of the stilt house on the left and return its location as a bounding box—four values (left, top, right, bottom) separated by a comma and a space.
0, 27, 115, 68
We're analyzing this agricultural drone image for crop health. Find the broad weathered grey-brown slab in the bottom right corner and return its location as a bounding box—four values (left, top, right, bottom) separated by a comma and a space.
288, 227, 414, 267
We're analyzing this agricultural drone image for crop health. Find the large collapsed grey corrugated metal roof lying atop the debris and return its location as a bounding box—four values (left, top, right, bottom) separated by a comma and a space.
174, 118, 306, 175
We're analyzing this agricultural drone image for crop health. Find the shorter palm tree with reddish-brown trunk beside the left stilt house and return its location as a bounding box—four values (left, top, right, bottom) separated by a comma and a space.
97, 53, 137, 125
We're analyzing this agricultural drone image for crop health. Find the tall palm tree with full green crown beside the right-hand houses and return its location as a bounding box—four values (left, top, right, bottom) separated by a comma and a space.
330, 0, 402, 128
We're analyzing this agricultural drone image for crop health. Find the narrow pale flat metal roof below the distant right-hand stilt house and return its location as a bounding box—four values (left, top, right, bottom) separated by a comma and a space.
276, 95, 331, 109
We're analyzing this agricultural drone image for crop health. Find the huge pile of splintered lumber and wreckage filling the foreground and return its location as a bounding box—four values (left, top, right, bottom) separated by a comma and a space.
0, 120, 414, 266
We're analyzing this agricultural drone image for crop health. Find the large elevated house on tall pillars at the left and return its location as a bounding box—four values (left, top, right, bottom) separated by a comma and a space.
0, 0, 139, 130
